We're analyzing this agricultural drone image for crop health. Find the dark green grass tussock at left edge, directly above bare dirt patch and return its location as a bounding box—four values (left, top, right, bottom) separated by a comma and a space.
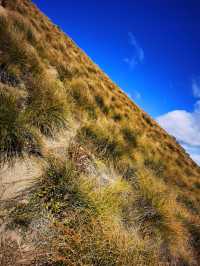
0, 92, 41, 166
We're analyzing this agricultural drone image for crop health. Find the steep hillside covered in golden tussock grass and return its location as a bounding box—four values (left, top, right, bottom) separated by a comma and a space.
0, 0, 200, 266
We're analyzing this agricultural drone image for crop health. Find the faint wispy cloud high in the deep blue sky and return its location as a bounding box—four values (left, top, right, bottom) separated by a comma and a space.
124, 32, 144, 69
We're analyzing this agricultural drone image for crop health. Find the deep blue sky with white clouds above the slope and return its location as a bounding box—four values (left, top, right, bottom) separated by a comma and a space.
34, 0, 200, 162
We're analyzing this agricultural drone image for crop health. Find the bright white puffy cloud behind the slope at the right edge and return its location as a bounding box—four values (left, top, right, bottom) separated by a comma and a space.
157, 80, 200, 165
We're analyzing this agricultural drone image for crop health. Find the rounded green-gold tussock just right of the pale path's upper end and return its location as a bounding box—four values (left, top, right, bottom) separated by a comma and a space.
77, 126, 126, 160
